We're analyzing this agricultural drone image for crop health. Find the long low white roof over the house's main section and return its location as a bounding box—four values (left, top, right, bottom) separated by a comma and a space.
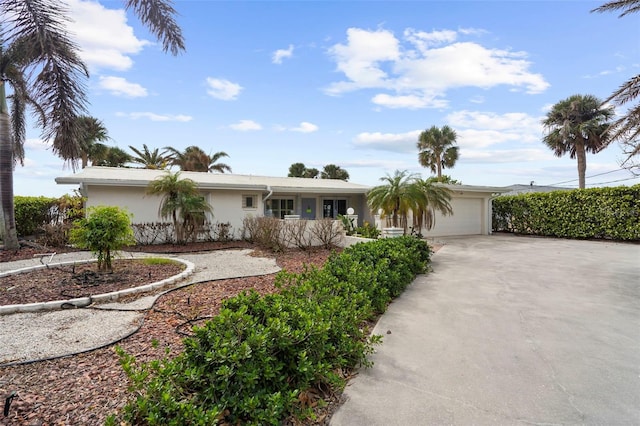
56, 167, 371, 194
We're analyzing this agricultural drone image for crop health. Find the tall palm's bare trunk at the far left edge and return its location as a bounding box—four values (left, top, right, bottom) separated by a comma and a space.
0, 81, 20, 250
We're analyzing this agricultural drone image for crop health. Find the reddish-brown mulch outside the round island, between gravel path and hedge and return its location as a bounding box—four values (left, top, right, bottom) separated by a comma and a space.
0, 242, 339, 425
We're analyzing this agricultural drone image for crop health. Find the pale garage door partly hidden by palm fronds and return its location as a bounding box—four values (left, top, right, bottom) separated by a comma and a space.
425, 198, 483, 237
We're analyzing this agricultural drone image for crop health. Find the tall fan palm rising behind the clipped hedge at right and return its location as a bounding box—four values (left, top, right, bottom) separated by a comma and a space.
542, 95, 614, 188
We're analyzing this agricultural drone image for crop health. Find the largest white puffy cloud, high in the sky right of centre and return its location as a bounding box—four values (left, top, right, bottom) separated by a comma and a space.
325, 28, 549, 108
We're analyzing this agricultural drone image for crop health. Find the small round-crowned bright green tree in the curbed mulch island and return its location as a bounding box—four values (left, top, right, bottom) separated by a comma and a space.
70, 206, 135, 271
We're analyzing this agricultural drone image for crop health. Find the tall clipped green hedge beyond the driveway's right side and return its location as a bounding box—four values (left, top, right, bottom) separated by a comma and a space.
493, 185, 640, 240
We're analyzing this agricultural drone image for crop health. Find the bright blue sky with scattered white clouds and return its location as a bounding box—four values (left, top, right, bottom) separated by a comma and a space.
14, 0, 640, 196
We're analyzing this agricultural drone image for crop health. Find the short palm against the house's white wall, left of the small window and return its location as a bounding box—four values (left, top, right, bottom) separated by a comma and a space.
147, 172, 211, 243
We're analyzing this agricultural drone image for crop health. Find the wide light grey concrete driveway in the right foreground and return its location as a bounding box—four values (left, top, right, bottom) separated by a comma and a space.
331, 235, 640, 426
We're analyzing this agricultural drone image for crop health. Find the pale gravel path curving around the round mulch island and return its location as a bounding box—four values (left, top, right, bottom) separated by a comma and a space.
0, 249, 280, 365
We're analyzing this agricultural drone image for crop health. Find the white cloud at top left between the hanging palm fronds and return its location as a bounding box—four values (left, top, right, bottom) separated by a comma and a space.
67, 0, 149, 71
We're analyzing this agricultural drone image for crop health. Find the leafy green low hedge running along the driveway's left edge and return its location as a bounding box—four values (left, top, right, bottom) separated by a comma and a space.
107, 237, 430, 425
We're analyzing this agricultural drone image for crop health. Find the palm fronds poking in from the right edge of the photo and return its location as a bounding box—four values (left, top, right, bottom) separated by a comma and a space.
592, 0, 640, 168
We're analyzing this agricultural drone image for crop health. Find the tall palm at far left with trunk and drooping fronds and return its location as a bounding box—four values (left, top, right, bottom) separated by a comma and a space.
0, 0, 184, 249
